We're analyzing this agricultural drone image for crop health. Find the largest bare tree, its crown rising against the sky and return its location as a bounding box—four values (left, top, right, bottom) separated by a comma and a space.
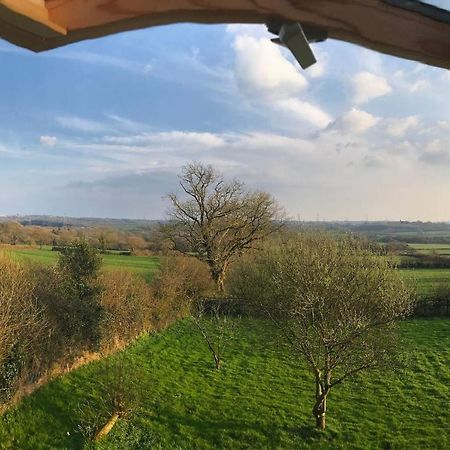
165, 163, 280, 292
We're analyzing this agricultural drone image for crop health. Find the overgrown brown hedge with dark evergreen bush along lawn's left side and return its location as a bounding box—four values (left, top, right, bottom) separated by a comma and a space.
0, 250, 214, 408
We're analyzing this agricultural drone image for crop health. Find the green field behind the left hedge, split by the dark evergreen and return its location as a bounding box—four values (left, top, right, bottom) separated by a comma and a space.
0, 246, 160, 279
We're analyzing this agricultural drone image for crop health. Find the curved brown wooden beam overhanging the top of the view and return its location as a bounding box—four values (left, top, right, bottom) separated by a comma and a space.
0, 0, 450, 69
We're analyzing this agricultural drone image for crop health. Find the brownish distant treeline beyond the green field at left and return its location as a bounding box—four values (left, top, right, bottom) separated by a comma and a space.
0, 221, 164, 253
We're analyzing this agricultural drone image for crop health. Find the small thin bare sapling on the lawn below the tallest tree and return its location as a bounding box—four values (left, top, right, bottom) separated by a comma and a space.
192, 299, 239, 370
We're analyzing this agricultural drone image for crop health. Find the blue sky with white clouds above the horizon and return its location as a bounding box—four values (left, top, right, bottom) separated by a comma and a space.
0, 20, 450, 221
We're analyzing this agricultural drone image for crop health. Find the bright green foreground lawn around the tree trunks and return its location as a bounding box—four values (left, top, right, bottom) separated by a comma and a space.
0, 319, 450, 450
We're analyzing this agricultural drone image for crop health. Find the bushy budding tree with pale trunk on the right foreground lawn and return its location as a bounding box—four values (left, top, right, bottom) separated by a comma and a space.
230, 233, 412, 430
